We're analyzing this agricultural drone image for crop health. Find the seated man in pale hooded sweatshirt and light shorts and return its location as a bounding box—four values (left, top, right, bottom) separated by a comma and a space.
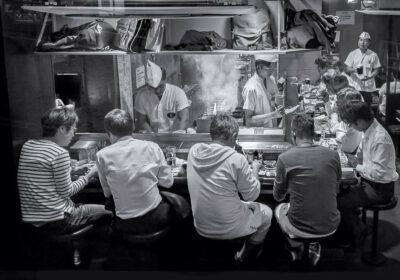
187, 114, 272, 262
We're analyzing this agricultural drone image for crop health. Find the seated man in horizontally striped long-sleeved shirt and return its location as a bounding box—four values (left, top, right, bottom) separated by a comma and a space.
18, 106, 112, 234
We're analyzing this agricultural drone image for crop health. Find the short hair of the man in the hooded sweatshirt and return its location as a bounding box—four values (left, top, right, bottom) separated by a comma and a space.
210, 113, 239, 141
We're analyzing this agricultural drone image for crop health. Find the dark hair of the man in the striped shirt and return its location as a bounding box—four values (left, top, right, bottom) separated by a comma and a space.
41, 105, 79, 137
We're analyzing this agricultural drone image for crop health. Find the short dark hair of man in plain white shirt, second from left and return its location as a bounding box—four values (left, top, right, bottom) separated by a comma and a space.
104, 109, 133, 137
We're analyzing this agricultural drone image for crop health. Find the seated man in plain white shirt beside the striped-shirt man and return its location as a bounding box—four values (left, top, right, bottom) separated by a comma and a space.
96, 109, 190, 234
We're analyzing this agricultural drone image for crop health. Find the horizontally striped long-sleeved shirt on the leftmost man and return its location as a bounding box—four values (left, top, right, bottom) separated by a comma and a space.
18, 139, 88, 225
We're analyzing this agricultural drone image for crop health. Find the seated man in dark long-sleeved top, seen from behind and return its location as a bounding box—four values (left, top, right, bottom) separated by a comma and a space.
273, 114, 342, 265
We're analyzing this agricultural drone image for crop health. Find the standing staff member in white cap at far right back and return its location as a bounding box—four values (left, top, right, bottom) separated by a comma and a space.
344, 32, 381, 105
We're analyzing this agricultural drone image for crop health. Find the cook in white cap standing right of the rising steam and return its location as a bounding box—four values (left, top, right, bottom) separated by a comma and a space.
242, 54, 281, 127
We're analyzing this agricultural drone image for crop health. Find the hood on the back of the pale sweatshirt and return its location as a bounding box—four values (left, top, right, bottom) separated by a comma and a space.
188, 143, 236, 172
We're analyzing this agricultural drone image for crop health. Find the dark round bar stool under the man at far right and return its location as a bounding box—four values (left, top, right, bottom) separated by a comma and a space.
361, 196, 397, 265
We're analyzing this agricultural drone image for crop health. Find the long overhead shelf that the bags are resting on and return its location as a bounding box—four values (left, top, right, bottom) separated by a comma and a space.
35, 49, 319, 55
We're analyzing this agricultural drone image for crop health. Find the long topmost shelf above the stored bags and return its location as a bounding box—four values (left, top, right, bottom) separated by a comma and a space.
22, 5, 255, 18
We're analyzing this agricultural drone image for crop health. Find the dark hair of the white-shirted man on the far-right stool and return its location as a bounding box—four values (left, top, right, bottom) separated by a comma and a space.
340, 100, 374, 124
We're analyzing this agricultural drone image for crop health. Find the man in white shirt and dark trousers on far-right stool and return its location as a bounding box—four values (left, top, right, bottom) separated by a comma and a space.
338, 101, 399, 245
